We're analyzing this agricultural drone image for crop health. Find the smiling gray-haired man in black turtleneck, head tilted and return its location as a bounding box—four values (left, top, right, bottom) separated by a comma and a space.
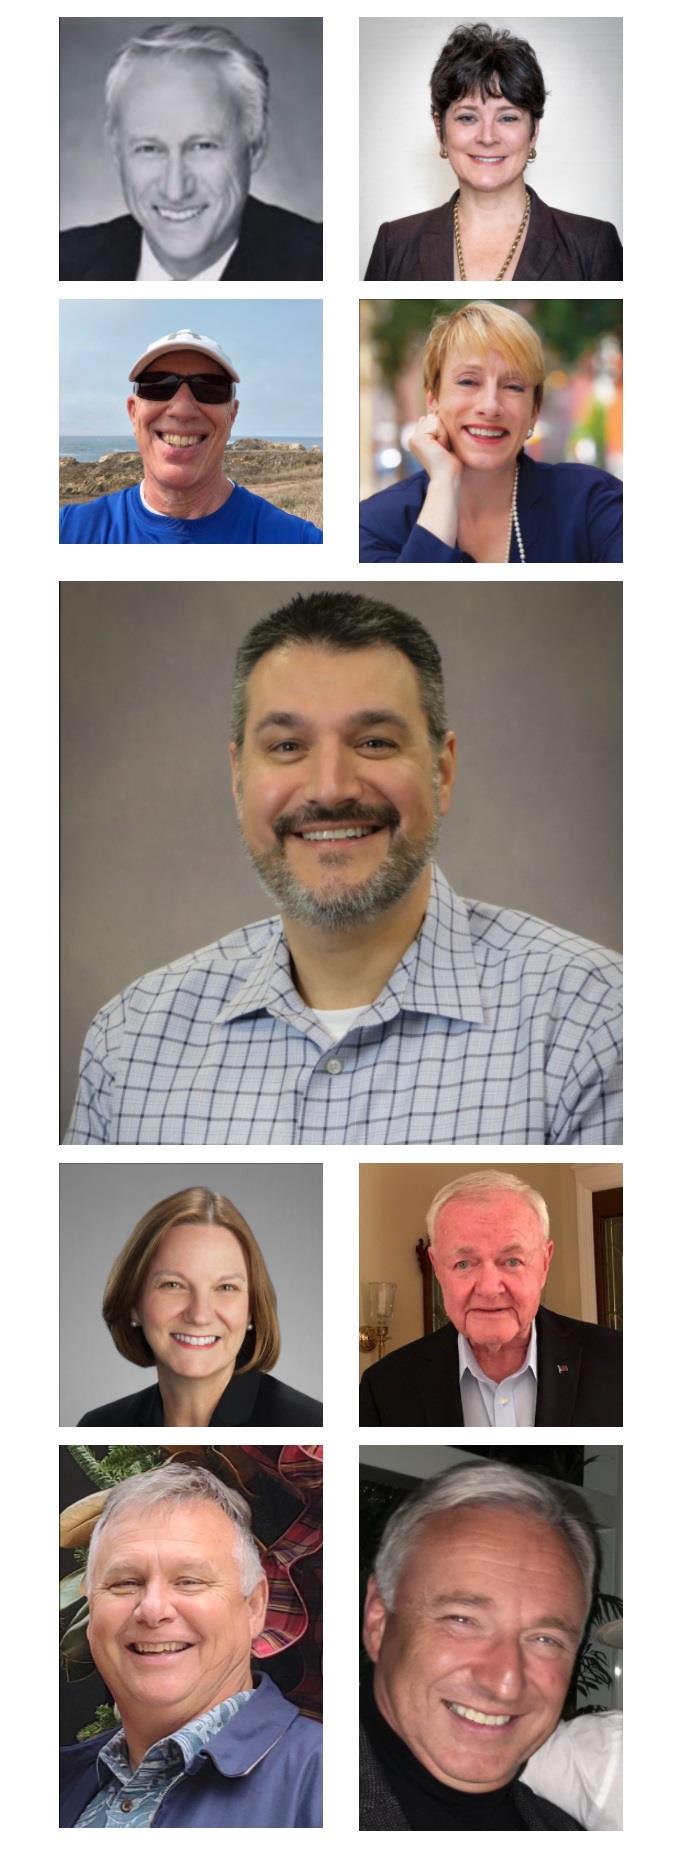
360, 1463, 597, 1832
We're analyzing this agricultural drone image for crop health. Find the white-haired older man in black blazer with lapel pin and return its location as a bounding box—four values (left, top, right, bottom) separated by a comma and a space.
360, 1169, 623, 1426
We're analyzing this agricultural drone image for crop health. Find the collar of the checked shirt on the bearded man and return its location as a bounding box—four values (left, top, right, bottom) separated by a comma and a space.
216, 868, 484, 1045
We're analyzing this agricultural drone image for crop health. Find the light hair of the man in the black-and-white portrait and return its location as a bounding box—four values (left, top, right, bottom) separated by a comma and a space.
104, 19, 270, 159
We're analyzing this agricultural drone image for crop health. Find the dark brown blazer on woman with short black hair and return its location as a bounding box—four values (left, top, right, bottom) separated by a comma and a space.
366, 187, 623, 283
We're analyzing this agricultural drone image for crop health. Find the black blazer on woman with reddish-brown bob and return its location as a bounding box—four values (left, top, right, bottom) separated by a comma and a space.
78, 1369, 322, 1426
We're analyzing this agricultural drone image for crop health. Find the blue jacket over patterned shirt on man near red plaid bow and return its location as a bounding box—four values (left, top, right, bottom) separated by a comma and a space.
59, 1672, 322, 1830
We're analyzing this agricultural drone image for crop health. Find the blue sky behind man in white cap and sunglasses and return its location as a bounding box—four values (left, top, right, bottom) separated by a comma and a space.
59, 296, 322, 437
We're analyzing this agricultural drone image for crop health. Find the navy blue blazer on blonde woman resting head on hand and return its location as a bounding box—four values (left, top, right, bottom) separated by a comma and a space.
360, 451, 623, 566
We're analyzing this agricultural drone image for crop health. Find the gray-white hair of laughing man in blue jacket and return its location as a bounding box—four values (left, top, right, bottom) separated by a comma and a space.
85, 1463, 262, 1597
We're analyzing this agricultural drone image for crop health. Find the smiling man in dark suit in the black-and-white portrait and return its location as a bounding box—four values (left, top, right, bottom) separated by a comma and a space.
59, 20, 322, 283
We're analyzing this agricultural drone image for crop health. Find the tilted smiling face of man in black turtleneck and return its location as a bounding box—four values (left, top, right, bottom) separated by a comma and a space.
364, 1508, 586, 1793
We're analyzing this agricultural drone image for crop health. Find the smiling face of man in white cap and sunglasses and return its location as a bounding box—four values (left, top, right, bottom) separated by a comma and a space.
128, 348, 238, 501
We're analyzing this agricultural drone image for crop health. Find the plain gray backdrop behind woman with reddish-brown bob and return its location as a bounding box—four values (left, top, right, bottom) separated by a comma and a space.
59, 1160, 322, 1426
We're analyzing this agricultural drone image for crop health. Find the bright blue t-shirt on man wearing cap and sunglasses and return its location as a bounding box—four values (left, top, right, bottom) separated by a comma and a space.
59, 483, 322, 546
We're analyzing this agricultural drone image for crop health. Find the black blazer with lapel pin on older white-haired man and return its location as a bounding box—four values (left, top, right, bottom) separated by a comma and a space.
360, 1306, 623, 1426
